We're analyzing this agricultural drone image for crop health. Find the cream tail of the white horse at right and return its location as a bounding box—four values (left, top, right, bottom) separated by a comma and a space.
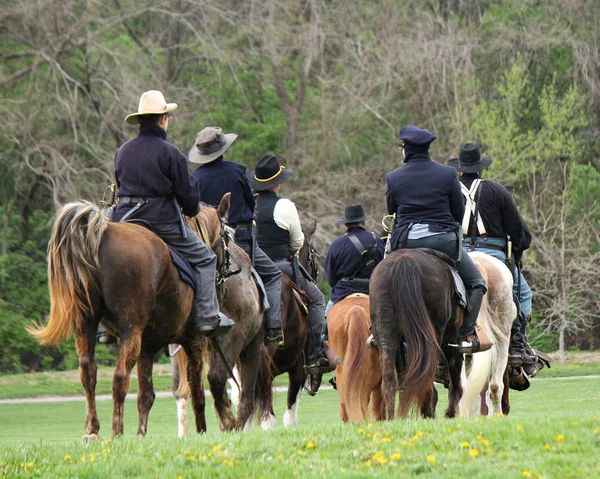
458, 288, 498, 416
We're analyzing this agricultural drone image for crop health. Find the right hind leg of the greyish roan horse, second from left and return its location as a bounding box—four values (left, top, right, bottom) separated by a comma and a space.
237, 334, 263, 431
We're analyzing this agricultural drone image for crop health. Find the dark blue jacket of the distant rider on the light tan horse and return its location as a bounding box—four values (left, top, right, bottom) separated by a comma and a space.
325, 226, 385, 303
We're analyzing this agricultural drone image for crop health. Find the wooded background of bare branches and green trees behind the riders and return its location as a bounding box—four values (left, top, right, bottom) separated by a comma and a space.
0, 0, 600, 371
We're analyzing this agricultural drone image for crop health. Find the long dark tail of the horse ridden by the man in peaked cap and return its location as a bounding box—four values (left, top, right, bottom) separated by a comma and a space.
391, 255, 440, 417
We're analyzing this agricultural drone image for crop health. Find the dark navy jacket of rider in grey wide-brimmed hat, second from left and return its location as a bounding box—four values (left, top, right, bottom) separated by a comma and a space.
192, 156, 254, 242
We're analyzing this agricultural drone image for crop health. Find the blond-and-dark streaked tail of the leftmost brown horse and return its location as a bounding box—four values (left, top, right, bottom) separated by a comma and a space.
28, 201, 108, 344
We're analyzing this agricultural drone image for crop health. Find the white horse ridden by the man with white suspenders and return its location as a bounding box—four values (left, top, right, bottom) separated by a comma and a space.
459, 252, 517, 416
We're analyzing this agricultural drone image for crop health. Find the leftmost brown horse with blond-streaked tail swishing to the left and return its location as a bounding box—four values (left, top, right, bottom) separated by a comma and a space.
30, 196, 229, 440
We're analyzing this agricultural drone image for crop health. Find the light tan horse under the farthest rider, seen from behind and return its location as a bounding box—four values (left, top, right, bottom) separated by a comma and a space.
327, 293, 383, 422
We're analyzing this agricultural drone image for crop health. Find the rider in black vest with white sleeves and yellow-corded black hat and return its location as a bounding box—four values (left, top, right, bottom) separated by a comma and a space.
248, 155, 334, 374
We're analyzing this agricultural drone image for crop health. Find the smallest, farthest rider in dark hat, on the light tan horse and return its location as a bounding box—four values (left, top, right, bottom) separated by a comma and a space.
325, 204, 385, 313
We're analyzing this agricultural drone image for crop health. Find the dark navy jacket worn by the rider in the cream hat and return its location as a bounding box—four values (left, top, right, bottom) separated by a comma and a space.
111, 125, 200, 223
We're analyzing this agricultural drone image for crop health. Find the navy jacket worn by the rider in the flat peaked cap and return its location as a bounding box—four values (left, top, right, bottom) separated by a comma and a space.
386, 153, 465, 249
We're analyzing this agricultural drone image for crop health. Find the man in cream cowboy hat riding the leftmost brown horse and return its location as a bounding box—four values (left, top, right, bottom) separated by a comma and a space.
106, 90, 233, 336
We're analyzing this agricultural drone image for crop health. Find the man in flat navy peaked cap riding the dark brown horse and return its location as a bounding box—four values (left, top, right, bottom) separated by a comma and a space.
386, 126, 487, 354
